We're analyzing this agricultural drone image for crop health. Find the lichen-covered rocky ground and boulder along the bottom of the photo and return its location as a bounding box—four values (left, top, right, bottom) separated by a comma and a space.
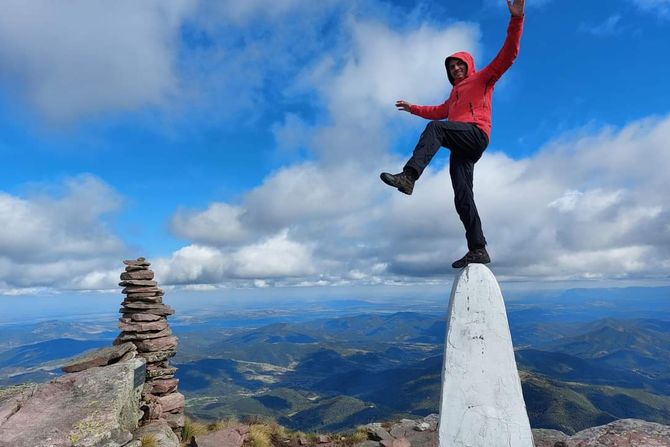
0, 360, 670, 447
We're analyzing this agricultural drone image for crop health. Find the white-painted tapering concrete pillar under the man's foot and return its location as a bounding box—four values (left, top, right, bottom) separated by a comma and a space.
439, 264, 534, 447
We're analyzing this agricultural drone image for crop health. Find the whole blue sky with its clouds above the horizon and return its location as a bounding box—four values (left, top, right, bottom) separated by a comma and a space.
0, 0, 670, 295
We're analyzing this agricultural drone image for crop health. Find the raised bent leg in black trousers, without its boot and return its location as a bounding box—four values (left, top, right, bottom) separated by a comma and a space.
403, 121, 488, 180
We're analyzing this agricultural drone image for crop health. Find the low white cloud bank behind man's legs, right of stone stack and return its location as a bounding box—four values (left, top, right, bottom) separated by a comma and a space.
165, 117, 670, 285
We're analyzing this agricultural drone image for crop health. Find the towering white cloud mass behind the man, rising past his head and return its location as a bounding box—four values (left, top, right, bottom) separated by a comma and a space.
155, 11, 670, 286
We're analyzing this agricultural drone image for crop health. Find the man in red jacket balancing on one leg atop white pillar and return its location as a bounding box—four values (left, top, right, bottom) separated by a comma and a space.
380, 0, 524, 268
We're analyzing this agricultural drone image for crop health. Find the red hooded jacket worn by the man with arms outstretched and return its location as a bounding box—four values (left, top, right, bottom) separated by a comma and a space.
410, 16, 523, 136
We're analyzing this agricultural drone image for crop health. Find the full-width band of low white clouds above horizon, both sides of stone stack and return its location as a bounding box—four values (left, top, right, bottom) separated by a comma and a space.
0, 117, 670, 294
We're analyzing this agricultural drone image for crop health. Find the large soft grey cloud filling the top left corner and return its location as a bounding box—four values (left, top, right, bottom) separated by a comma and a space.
0, 0, 195, 124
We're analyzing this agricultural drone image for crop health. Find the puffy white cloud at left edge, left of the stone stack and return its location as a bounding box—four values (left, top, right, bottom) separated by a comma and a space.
0, 175, 125, 293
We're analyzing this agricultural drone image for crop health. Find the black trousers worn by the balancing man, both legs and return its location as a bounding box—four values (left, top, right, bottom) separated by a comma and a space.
404, 121, 489, 250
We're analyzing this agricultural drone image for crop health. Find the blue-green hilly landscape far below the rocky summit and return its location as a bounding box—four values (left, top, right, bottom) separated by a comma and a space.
0, 310, 670, 433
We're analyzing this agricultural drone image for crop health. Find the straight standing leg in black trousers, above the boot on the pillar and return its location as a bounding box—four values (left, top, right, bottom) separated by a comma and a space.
449, 152, 486, 251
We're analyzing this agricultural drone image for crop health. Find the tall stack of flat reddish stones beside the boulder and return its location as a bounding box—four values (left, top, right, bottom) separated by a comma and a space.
114, 258, 184, 436
